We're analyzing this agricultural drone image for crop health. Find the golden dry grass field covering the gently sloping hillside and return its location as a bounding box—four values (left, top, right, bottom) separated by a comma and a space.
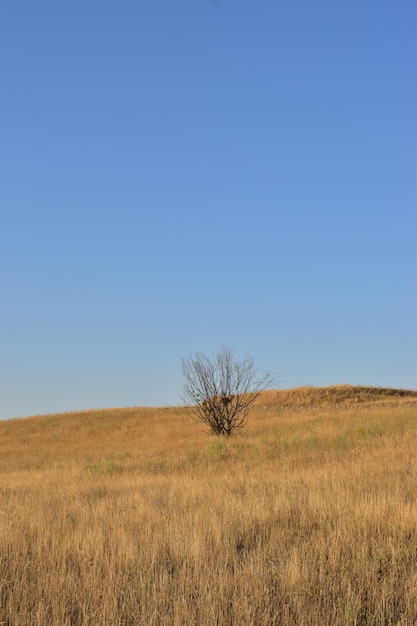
0, 386, 417, 626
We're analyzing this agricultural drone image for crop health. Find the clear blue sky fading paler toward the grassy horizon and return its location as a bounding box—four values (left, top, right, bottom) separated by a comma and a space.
0, 0, 417, 419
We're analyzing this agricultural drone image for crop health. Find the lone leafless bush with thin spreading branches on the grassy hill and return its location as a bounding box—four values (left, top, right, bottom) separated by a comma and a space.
181, 348, 275, 437
